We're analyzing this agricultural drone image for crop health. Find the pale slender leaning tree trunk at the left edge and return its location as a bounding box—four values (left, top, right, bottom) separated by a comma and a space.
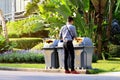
0, 9, 9, 42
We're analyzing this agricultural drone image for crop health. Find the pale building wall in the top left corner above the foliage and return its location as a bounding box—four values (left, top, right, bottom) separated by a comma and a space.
0, 0, 32, 17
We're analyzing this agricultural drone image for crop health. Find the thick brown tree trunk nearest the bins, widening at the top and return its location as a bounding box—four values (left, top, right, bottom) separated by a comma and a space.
91, 0, 107, 57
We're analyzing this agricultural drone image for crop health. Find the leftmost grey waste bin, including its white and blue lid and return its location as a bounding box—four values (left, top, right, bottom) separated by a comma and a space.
43, 39, 59, 69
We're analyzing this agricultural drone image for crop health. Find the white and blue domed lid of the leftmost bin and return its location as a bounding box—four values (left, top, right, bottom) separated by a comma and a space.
43, 39, 59, 48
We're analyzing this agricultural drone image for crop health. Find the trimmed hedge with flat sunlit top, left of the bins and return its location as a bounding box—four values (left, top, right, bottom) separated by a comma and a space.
10, 38, 43, 49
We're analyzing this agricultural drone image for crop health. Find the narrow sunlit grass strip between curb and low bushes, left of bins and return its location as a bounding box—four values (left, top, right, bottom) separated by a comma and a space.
0, 63, 45, 69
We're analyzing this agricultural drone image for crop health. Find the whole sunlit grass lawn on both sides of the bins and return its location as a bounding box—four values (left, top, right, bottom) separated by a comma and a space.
0, 58, 120, 74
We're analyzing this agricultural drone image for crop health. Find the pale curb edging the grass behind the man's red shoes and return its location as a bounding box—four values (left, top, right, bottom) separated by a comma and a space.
0, 67, 86, 74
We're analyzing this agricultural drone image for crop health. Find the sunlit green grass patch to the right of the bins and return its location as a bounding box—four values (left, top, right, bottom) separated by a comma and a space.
88, 58, 120, 73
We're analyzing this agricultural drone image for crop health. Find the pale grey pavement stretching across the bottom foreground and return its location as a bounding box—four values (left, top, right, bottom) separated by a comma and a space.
0, 70, 120, 80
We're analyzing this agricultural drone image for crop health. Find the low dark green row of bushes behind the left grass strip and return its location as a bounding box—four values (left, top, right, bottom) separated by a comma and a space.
0, 52, 45, 63
